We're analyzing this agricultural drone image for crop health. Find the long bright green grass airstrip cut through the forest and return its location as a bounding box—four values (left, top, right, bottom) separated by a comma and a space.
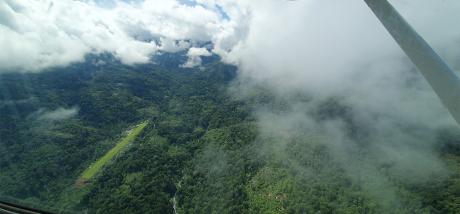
77, 121, 148, 185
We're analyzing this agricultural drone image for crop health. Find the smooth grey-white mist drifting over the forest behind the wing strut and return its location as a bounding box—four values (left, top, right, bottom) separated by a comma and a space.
228, 1, 460, 209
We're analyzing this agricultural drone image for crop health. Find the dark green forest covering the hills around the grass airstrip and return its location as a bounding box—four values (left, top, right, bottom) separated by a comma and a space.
0, 54, 460, 213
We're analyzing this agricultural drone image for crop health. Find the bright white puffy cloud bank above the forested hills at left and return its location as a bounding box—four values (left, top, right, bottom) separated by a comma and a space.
0, 0, 229, 72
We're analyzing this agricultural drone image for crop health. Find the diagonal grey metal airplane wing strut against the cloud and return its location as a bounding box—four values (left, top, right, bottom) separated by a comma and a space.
364, 0, 460, 125
